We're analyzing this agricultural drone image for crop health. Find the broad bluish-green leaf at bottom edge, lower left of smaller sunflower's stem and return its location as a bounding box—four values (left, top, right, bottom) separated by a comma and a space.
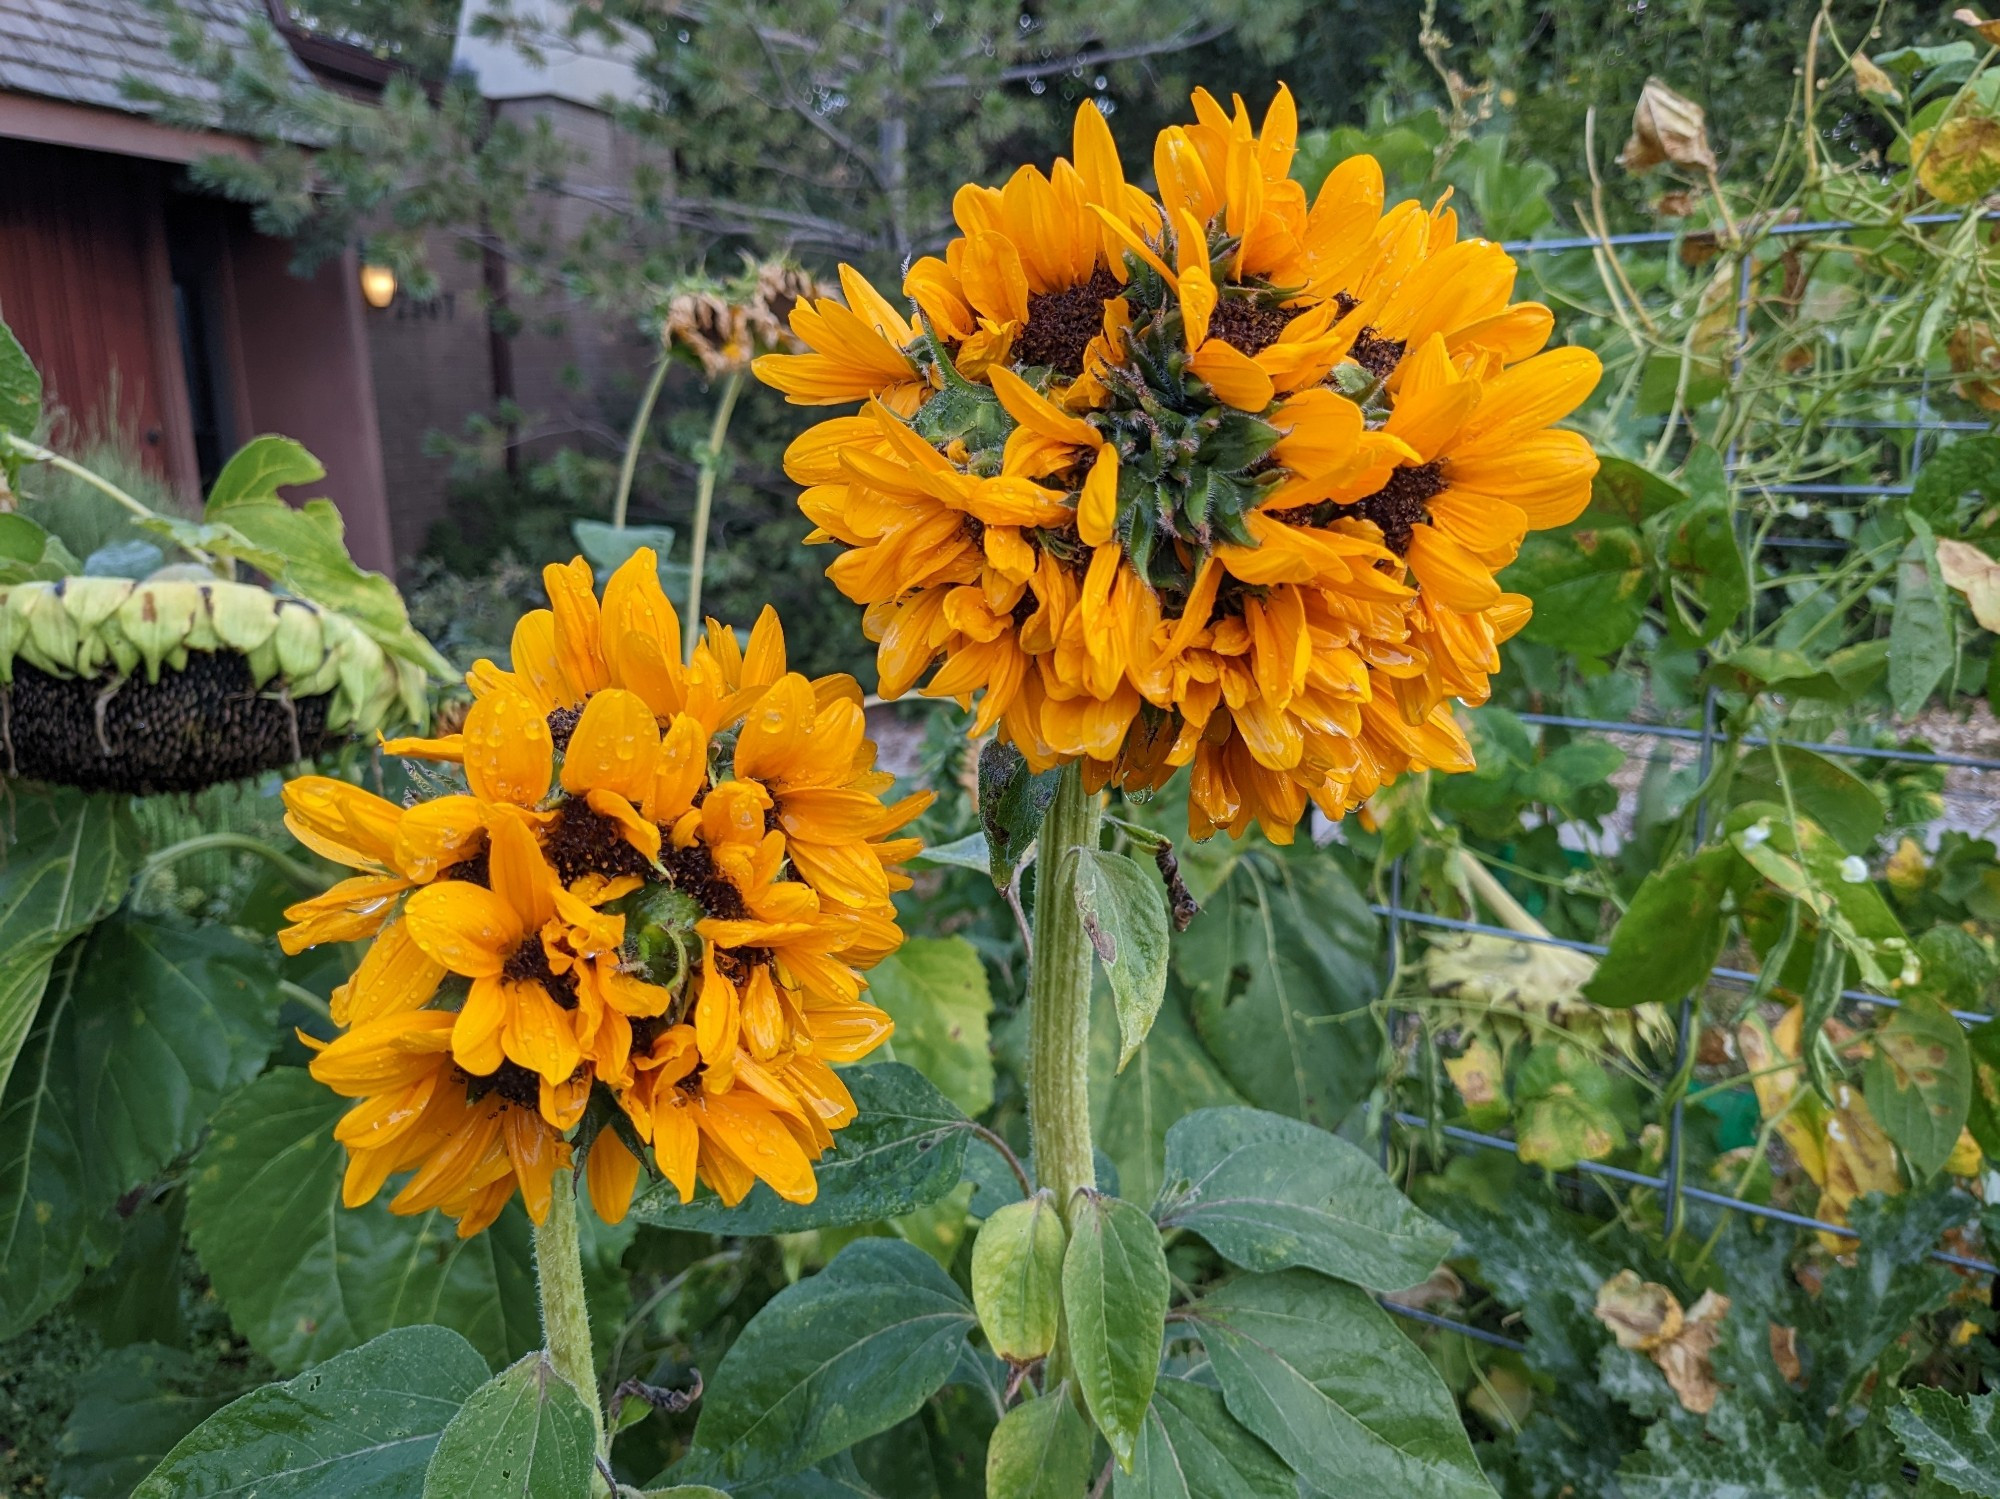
132, 1327, 486, 1499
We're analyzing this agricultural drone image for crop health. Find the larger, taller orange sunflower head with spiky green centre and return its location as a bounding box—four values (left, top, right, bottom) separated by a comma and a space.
770, 86, 1598, 839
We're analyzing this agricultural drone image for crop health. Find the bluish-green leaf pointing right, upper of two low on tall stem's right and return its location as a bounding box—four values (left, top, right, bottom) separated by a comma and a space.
1156, 1109, 1452, 1291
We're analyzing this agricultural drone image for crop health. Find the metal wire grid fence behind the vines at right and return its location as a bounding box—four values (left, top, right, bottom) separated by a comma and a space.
1372, 214, 2000, 1351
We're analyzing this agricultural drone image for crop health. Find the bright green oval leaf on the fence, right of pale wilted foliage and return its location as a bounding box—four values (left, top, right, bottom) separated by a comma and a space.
1584, 847, 1742, 1009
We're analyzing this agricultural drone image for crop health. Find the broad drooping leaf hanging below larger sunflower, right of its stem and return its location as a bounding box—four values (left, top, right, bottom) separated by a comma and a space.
1176, 849, 1382, 1129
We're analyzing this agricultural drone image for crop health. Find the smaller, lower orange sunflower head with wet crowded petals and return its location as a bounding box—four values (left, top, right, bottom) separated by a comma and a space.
284, 550, 928, 1233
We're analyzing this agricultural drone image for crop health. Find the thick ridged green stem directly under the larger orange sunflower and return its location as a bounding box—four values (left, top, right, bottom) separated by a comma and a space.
1028, 763, 1102, 1217
